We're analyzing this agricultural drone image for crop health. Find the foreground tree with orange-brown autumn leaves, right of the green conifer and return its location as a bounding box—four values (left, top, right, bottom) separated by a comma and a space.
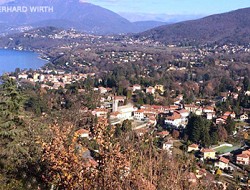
41, 125, 95, 189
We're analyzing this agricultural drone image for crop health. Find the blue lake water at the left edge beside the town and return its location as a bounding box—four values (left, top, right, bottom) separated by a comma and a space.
0, 49, 47, 75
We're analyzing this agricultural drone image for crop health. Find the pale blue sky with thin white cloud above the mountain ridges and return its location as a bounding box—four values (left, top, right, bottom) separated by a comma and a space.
0, 0, 250, 21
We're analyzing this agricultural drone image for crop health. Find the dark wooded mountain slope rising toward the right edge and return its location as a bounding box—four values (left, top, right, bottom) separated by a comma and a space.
135, 8, 250, 44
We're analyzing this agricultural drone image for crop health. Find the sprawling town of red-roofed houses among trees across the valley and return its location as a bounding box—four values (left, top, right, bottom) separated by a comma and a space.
2, 26, 250, 188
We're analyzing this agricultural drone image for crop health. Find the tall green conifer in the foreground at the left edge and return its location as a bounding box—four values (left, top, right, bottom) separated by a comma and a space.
0, 78, 44, 189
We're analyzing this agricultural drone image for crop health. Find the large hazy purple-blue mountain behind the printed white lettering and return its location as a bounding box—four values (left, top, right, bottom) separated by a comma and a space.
0, 0, 166, 34
